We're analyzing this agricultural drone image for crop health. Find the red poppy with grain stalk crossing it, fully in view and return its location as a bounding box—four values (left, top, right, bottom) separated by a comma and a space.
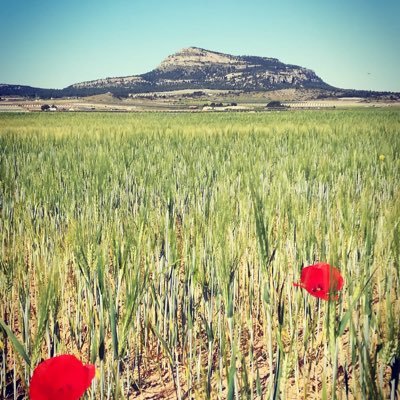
293, 263, 344, 300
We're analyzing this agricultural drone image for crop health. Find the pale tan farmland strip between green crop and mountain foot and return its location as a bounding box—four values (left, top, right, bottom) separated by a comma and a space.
0, 89, 400, 115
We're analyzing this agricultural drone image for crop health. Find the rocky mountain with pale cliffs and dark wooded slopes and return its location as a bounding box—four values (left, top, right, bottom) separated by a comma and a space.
0, 47, 396, 97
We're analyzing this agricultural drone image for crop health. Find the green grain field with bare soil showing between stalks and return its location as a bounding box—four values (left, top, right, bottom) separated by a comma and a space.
0, 109, 400, 399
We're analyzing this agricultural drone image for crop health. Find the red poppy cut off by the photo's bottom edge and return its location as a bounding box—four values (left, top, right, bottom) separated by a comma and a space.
29, 354, 95, 400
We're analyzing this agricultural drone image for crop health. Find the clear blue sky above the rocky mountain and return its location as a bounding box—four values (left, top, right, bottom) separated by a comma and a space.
0, 0, 400, 91
